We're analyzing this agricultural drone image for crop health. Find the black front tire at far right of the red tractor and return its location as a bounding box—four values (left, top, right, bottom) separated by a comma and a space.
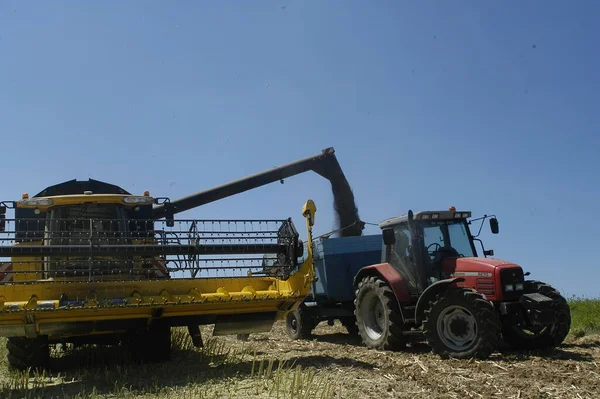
502, 282, 571, 350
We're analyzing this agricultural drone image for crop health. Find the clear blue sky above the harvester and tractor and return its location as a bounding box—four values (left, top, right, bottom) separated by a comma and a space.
0, 0, 600, 296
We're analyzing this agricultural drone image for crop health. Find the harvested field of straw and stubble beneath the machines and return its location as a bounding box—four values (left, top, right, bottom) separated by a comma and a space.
0, 322, 600, 399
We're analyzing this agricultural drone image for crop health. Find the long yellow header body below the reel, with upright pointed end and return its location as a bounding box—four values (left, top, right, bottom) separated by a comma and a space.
0, 196, 316, 334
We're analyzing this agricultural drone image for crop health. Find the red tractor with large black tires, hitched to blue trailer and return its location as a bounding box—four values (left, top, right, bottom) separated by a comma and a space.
354, 207, 571, 359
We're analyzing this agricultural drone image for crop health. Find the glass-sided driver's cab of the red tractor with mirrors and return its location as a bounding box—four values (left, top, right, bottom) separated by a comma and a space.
380, 207, 498, 296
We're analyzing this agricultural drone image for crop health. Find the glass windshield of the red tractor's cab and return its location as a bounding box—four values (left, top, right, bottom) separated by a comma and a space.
423, 220, 476, 261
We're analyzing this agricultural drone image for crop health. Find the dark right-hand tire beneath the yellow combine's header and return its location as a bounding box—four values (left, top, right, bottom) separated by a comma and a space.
127, 321, 171, 363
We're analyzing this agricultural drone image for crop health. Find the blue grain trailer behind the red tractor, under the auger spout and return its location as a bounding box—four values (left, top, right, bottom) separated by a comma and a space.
286, 234, 383, 339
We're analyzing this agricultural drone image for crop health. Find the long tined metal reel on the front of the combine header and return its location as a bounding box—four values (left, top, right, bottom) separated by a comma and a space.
0, 219, 302, 284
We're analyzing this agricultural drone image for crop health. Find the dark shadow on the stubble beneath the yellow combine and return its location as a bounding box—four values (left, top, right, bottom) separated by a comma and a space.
0, 346, 375, 398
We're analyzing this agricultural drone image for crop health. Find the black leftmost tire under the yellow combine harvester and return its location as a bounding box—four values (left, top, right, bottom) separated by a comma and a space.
6, 336, 50, 371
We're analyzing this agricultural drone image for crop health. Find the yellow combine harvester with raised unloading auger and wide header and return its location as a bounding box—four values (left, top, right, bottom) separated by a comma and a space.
0, 149, 358, 369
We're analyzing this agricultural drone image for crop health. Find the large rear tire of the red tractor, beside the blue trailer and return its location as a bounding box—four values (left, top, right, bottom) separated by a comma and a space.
354, 276, 406, 350
